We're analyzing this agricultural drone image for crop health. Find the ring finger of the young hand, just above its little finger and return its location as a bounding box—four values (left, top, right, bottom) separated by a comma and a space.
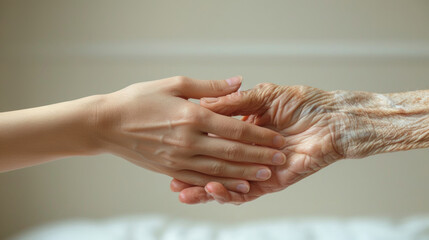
183, 155, 271, 181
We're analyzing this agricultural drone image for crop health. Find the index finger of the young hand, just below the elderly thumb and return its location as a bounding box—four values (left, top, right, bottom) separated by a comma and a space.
200, 113, 285, 148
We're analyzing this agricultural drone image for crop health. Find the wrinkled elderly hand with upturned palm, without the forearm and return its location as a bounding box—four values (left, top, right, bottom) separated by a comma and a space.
170, 84, 371, 204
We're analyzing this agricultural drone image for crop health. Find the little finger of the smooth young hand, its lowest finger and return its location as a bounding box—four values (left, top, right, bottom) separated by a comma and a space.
175, 170, 250, 193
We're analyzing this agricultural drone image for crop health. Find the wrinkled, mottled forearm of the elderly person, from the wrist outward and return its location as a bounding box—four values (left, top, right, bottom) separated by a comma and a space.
334, 91, 429, 158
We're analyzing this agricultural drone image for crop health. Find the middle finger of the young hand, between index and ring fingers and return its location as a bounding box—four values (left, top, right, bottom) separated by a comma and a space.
195, 137, 286, 165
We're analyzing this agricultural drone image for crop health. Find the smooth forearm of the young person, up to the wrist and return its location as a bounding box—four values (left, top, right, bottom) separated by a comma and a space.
0, 96, 99, 172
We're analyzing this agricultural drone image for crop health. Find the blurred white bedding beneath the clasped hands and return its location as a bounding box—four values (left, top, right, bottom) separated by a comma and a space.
8, 216, 429, 240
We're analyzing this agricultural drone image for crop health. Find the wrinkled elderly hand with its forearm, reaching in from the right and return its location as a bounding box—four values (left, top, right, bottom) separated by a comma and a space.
170, 84, 429, 204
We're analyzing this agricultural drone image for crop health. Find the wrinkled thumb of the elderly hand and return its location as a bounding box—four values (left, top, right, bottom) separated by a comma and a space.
200, 86, 267, 116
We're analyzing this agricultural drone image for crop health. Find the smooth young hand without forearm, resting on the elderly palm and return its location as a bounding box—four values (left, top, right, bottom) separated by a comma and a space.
96, 77, 286, 193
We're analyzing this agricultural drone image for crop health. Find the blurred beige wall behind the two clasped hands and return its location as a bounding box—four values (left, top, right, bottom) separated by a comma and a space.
0, 0, 429, 238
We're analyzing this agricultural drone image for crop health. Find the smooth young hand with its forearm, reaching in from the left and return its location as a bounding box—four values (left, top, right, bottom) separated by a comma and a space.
0, 77, 286, 193
